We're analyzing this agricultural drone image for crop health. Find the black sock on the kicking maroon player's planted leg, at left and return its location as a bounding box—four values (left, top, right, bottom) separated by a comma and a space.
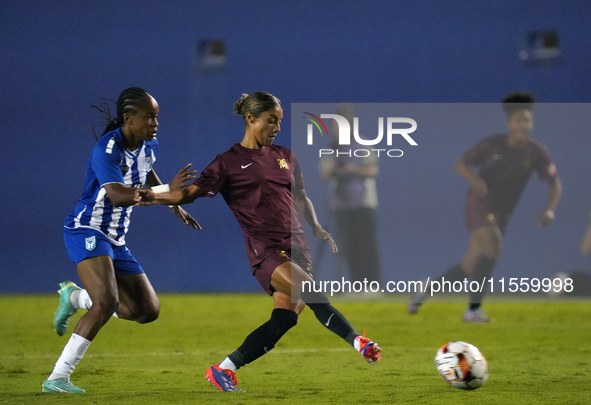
228, 308, 298, 369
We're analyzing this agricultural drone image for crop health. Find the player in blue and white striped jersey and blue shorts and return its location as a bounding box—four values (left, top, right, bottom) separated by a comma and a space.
42, 87, 199, 393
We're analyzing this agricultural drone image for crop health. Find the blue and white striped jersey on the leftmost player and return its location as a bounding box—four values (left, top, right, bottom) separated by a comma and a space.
64, 128, 158, 246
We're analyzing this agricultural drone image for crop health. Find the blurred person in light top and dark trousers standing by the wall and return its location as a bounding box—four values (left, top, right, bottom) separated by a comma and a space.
320, 104, 381, 288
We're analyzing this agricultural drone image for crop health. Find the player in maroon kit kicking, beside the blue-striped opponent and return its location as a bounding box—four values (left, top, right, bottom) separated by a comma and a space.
136, 92, 381, 391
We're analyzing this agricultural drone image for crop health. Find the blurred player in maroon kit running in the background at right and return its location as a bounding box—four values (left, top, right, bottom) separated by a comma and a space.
408, 92, 562, 322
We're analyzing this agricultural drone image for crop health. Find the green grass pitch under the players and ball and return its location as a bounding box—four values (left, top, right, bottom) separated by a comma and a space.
0, 294, 591, 405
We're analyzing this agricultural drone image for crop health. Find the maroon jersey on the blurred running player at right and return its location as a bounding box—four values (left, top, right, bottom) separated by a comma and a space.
464, 134, 557, 215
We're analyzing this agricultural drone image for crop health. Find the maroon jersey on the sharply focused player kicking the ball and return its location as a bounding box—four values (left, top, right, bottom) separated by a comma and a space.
193, 144, 311, 266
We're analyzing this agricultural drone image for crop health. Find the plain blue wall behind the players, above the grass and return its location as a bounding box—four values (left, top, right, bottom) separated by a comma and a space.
0, 0, 591, 292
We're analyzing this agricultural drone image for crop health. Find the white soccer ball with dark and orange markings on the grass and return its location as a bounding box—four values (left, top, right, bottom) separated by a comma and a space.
435, 341, 488, 390
